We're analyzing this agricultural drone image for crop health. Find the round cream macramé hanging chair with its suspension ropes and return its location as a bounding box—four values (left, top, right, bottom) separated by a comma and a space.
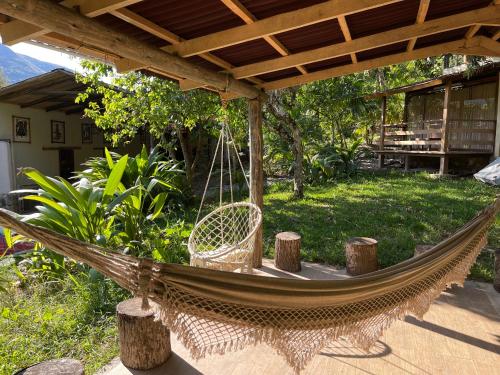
188, 103, 262, 273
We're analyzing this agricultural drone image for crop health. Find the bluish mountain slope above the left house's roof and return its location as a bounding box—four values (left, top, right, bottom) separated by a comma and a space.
0, 44, 62, 84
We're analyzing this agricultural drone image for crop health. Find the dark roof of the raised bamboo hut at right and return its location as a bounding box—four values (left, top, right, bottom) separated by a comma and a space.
365, 62, 500, 99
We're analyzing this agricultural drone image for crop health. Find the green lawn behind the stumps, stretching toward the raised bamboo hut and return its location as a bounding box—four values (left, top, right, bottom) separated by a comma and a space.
264, 172, 500, 281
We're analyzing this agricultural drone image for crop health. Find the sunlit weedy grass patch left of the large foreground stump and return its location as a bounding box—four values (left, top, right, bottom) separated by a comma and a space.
0, 268, 128, 375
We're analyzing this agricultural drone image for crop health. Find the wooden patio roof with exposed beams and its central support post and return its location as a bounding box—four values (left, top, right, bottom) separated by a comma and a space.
0, 0, 500, 267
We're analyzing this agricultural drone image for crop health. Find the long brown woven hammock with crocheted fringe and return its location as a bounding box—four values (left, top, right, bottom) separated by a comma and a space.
0, 199, 500, 372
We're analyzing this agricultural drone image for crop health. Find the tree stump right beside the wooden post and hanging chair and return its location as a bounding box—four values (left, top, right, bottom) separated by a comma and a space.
274, 232, 300, 272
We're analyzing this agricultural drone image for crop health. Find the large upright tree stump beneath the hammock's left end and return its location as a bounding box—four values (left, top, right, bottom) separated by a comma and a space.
116, 298, 172, 370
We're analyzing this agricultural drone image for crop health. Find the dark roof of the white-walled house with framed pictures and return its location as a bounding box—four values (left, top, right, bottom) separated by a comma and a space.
0, 69, 94, 114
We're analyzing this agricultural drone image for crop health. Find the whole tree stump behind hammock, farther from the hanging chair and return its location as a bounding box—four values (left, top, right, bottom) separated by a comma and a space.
345, 237, 378, 275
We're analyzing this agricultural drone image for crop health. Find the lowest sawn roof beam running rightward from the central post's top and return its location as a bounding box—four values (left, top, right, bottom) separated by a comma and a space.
262, 37, 484, 90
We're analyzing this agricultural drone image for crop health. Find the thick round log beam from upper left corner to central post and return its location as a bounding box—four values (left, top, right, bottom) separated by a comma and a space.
0, 0, 262, 98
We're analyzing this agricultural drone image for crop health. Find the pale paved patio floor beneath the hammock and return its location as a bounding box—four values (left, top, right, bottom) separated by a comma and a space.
101, 261, 500, 375
